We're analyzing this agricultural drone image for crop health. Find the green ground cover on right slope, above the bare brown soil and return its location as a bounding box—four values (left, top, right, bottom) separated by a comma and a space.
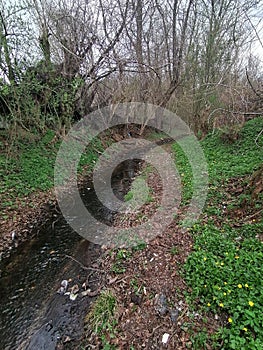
172, 118, 263, 206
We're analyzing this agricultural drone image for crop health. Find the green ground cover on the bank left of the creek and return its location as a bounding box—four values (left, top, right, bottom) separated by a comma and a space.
0, 130, 102, 209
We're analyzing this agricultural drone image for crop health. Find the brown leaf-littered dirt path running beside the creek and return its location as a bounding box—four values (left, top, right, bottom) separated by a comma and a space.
83, 142, 220, 350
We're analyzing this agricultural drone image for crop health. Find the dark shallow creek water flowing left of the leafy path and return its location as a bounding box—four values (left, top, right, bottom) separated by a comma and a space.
0, 161, 141, 350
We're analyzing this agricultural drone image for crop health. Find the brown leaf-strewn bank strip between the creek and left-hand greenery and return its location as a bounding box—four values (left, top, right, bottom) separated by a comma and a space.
0, 131, 173, 261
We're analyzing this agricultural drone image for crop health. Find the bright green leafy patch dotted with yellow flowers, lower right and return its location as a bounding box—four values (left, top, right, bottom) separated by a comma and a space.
185, 223, 263, 349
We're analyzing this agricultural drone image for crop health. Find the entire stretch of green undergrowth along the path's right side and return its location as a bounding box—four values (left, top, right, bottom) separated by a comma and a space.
182, 118, 263, 350
